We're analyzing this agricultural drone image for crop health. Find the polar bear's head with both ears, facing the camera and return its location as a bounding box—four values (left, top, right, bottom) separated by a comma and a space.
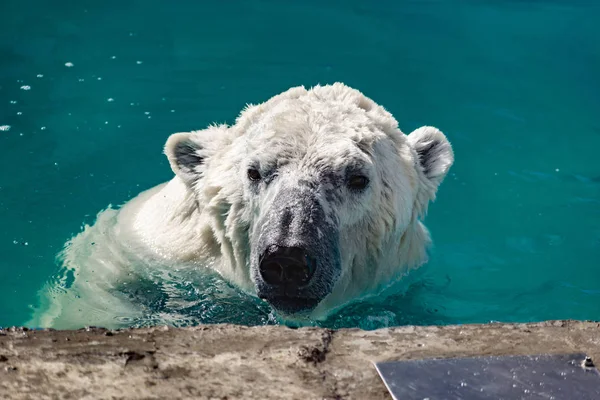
165, 83, 454, 315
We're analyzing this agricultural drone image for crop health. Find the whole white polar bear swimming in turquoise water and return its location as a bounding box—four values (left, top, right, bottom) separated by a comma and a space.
31, 83, 454, 328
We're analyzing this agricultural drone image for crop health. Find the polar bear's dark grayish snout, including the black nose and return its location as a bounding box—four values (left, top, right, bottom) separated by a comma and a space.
250, 181, 341, 315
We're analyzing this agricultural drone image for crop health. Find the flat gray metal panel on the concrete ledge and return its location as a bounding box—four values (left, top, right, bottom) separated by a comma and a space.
375, 354, 600, 400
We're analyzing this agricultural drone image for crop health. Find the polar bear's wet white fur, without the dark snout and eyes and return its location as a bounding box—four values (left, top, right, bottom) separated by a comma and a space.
30, 83, 454, 328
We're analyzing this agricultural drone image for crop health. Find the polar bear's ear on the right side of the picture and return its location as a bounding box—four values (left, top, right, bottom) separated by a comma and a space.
408, 126, 454, 214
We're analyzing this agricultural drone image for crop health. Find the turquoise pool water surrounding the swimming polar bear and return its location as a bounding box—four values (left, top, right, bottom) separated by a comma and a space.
0, 0, 600, 328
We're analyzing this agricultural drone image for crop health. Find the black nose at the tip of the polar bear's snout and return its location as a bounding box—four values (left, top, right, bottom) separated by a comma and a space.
259, 246, 315, 288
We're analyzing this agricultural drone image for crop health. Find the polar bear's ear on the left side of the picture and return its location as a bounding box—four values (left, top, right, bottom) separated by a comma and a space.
165, 132, 207, 186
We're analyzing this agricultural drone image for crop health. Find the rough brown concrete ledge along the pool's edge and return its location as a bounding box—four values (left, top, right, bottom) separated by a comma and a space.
0, 321, 600, 399
